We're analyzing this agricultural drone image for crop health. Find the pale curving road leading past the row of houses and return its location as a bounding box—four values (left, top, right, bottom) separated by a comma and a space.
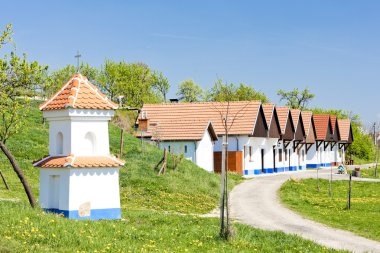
230, 170, 380, 252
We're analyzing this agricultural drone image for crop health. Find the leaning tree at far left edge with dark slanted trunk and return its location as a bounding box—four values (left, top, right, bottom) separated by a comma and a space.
0, 24, 47, 207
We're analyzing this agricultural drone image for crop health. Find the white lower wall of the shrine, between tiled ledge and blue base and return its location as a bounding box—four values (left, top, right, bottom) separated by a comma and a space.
39, 168, 120, 211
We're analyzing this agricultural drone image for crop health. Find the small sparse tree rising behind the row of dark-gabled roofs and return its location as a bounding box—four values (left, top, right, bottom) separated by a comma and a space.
277, 88, 315, 110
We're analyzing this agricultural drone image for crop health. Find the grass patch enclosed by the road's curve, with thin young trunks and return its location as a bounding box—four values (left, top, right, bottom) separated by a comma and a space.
280, 179, 380, 241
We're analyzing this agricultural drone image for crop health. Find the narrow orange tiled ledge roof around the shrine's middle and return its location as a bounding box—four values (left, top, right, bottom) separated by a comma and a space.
33, 155, 124, 168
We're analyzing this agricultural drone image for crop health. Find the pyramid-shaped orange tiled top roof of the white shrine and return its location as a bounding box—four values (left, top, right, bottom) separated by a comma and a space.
39, 74, 118, 111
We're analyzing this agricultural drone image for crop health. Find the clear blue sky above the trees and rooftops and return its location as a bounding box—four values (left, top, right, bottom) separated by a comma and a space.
0, 0, 380, 124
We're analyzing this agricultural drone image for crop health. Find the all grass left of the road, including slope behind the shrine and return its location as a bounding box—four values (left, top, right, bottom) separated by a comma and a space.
0, 103, 342, 252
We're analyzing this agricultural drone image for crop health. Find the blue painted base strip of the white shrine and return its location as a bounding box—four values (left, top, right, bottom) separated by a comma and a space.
44, 208, 121, 220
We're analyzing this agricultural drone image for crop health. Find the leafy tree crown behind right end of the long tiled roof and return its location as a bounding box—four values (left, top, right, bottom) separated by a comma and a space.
206, 79, 269, 103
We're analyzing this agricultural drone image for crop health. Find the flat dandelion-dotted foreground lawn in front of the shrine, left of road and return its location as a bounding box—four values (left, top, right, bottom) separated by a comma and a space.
0, 201, 337, 252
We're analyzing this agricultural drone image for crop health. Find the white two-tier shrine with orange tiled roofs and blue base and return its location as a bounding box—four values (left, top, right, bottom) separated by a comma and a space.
34, 74, 124, 220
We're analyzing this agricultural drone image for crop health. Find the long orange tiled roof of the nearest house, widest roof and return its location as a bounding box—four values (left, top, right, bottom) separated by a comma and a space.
141, 101, 261, 138
